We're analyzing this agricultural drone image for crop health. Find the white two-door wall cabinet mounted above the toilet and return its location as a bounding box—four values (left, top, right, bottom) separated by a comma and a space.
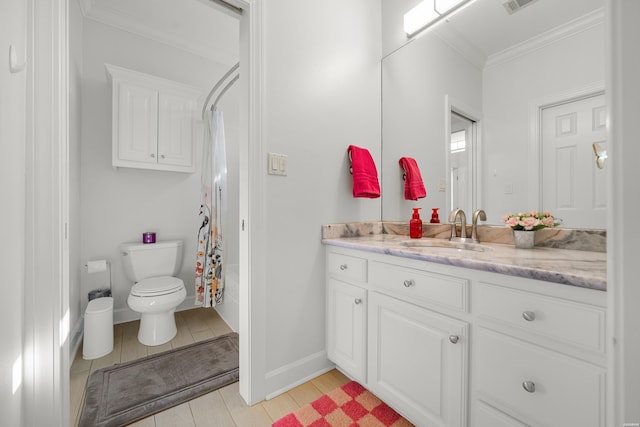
105, 64, 201, 172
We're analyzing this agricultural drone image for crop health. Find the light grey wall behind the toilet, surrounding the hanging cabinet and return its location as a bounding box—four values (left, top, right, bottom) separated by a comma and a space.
78, 19, 238, 322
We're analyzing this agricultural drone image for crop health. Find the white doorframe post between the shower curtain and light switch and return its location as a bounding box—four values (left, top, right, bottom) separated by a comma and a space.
232, 0, 267, 405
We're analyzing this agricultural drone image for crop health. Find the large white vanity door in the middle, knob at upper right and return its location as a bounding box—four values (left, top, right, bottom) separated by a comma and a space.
368, 292, 468, 427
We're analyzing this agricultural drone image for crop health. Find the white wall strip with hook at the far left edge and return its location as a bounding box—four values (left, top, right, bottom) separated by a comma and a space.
0, 0, 27, 426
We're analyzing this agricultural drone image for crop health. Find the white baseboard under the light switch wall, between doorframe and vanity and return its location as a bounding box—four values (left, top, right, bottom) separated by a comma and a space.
265, 351, 335, 400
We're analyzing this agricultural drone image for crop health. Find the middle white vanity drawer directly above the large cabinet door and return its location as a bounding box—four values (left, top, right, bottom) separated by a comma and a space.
369, 261, 469, 311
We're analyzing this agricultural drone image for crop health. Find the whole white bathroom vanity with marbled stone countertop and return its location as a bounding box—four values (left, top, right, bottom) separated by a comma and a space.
323, 226, 606, 427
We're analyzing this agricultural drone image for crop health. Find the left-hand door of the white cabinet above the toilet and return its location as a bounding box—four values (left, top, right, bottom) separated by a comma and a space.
113, 82, 158, 166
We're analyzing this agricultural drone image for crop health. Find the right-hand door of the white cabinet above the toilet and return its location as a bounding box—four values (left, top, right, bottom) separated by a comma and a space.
158, 93, 196, 167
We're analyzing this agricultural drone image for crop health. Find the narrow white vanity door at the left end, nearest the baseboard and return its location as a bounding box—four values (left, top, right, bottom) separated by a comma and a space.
327, 279, 366, 383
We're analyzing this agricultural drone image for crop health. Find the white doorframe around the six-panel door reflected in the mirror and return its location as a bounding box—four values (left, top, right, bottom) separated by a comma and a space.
527, 81, 605, 210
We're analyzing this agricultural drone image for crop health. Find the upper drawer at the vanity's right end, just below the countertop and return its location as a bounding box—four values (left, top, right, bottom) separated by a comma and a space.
473, 282, 605, 353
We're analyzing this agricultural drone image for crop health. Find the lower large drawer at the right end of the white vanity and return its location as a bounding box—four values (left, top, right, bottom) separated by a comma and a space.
474, 328, 605, 427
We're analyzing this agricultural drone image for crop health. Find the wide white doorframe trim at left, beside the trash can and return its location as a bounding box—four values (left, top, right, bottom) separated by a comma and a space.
22, 0, 70, 425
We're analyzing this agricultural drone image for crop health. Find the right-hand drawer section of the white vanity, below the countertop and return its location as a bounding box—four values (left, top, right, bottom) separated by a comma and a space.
472, 281, 606, 427
